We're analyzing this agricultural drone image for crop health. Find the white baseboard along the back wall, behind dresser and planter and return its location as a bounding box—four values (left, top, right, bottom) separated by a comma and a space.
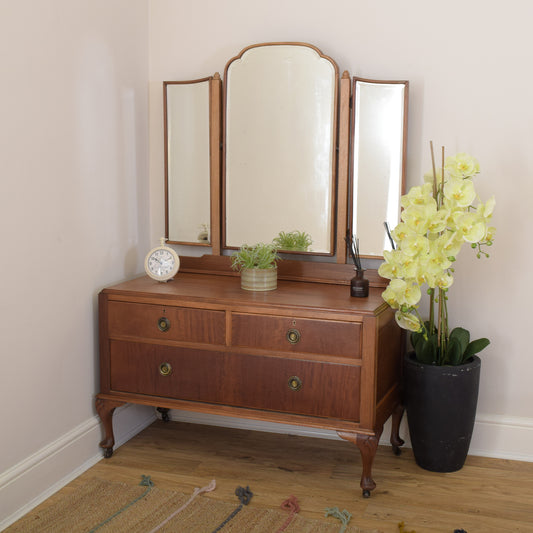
163, 410, 533, 462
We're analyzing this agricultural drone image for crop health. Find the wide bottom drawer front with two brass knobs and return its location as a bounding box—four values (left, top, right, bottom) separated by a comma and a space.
110, 341, 361, 422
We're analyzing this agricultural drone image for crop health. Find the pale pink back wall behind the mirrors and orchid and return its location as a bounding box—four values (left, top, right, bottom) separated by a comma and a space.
150, 0, 533, 442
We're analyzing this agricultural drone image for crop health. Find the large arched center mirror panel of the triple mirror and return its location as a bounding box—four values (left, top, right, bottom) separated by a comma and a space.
223, 43, 338, 255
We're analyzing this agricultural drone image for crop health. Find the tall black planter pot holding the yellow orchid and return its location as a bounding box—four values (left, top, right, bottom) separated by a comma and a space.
404, 353, 481, 472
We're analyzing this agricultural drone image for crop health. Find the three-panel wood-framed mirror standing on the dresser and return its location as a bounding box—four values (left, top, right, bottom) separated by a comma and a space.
163, 43, 408, 262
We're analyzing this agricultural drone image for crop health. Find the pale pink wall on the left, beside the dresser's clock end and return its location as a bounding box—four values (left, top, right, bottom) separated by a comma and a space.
0, 0, 149, 472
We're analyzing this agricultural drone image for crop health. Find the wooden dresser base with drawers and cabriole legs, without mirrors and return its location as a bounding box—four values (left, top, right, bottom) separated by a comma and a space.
96, 265, 403, 496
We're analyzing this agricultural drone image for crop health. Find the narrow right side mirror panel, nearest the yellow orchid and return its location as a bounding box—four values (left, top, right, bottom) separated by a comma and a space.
352, 78, 408, 257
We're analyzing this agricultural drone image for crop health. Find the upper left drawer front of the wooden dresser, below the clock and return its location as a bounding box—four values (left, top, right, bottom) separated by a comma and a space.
108, 302, 226, 345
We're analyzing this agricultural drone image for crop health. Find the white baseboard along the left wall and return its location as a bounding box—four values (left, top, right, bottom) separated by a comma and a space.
0, 404, 155, 531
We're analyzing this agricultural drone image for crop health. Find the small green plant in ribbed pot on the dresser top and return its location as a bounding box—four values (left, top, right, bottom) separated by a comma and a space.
231, 243, 279, 291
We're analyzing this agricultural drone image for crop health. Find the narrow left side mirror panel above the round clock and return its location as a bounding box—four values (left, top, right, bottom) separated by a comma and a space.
163, 78, 211, 246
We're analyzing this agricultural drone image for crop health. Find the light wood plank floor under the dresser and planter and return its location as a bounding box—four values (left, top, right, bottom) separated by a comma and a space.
42, 421, 533, 533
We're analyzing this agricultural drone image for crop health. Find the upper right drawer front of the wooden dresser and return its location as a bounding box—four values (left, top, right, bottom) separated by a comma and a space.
231, 313, 361, 358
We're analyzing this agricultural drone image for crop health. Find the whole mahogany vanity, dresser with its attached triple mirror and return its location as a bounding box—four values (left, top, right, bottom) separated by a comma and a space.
96, 43, 408, 496
